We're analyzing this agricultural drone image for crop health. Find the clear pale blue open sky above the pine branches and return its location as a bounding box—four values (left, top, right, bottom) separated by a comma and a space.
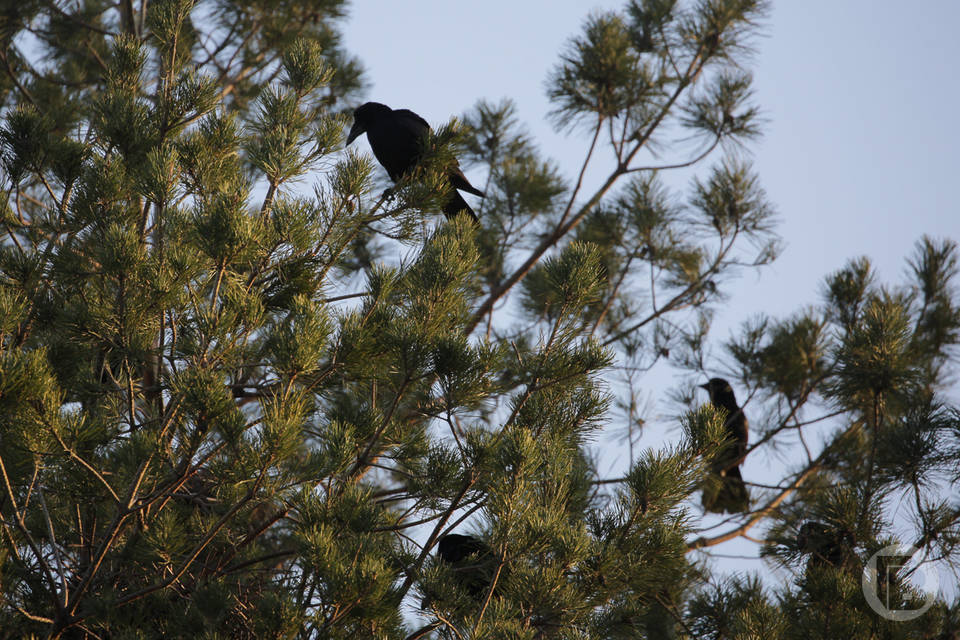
345, 0, 960, 592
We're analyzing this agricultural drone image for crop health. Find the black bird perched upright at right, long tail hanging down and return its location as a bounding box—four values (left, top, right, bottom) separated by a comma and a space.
700, 378, 750, 513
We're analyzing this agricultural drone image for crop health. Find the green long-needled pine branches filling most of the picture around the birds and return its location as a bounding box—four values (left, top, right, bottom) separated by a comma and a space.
0, 0, 960, 639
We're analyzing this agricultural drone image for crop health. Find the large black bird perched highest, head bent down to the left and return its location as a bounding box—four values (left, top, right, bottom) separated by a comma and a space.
347, 102, 484, 222
